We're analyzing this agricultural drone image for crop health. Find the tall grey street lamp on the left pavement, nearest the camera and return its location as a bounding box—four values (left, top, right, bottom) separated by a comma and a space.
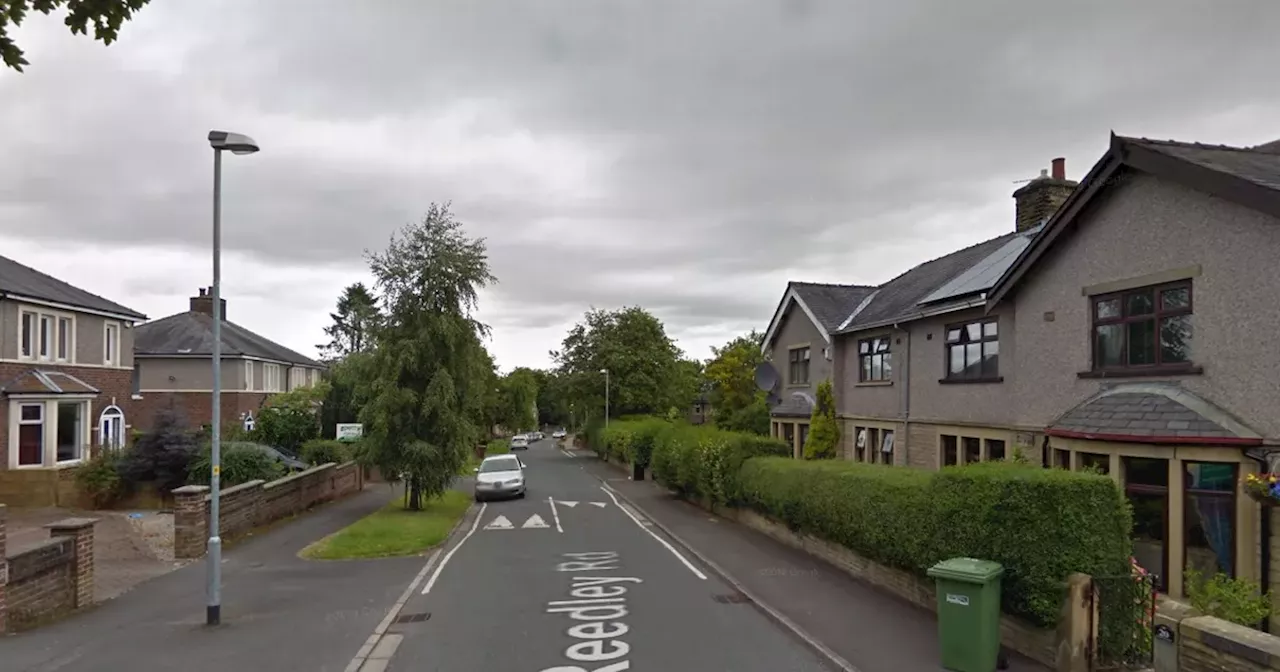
205, 131, 259, 626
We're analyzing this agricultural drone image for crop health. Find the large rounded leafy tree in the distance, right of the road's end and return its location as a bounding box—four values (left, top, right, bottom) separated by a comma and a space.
550, 306, 692, 417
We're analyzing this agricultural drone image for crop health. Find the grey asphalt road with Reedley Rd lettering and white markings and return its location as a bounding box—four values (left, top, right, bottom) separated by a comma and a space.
373, 439, 828, 672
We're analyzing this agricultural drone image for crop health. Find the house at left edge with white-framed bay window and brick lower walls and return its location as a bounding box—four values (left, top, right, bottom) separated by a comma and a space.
0, 256, 146, 506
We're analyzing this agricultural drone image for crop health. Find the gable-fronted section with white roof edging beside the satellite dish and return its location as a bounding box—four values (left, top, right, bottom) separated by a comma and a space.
760, 282, 876, 457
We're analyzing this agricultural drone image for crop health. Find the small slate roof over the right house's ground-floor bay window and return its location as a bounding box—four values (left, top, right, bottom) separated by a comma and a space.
1047, 383, 1262, 444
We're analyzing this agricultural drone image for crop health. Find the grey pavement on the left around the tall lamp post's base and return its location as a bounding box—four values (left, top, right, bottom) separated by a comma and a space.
0, 484, 425, 672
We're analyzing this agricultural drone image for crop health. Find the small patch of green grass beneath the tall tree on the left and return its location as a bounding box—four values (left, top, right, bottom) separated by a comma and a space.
301, 490, 471, 559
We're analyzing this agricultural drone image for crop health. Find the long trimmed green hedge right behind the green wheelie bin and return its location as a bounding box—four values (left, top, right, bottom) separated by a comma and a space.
737, 458, 1133, 626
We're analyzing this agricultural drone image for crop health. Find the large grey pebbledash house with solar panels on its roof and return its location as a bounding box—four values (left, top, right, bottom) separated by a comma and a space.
757, 136, 1280, 630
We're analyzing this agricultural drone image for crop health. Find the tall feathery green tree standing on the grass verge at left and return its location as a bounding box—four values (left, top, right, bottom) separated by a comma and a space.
360, 204, 497, 511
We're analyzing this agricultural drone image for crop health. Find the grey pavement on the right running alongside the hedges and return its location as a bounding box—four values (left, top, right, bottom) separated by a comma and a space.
571, 451, 1048, 672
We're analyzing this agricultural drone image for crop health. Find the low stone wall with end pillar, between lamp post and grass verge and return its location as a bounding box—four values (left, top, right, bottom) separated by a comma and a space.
173, 462, 365, 558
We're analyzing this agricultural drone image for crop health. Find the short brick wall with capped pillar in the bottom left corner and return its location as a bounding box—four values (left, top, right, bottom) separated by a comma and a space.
0, 504, 96, 634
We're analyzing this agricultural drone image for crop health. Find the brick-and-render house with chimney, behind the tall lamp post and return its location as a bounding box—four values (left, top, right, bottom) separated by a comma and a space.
133, 288, 324, 428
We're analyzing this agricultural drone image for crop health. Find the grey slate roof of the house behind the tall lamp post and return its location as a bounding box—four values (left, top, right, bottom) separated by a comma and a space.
133, 311, 324, 367
